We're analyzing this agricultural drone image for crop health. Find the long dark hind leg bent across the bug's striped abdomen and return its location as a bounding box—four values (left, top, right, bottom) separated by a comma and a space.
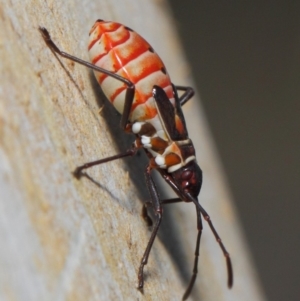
39, 27, 135, 130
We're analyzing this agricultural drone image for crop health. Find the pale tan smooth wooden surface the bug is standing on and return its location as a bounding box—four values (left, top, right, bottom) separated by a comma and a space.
0, 0, 264, 301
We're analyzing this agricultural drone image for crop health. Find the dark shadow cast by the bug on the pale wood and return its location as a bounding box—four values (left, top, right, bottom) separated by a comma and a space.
83, 72, 201, 296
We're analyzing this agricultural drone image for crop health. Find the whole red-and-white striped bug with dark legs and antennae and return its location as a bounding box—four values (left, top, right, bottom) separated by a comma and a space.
39, 20, 233, 300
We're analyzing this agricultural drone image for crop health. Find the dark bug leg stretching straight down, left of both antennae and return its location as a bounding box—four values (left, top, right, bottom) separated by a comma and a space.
138, 165, 162, 289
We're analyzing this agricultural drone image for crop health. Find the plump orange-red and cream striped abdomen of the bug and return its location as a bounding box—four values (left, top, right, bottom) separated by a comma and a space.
88, 21, 174, 125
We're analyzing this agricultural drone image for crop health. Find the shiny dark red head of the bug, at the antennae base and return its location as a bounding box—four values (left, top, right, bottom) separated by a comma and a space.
172, 161, 202, 198
